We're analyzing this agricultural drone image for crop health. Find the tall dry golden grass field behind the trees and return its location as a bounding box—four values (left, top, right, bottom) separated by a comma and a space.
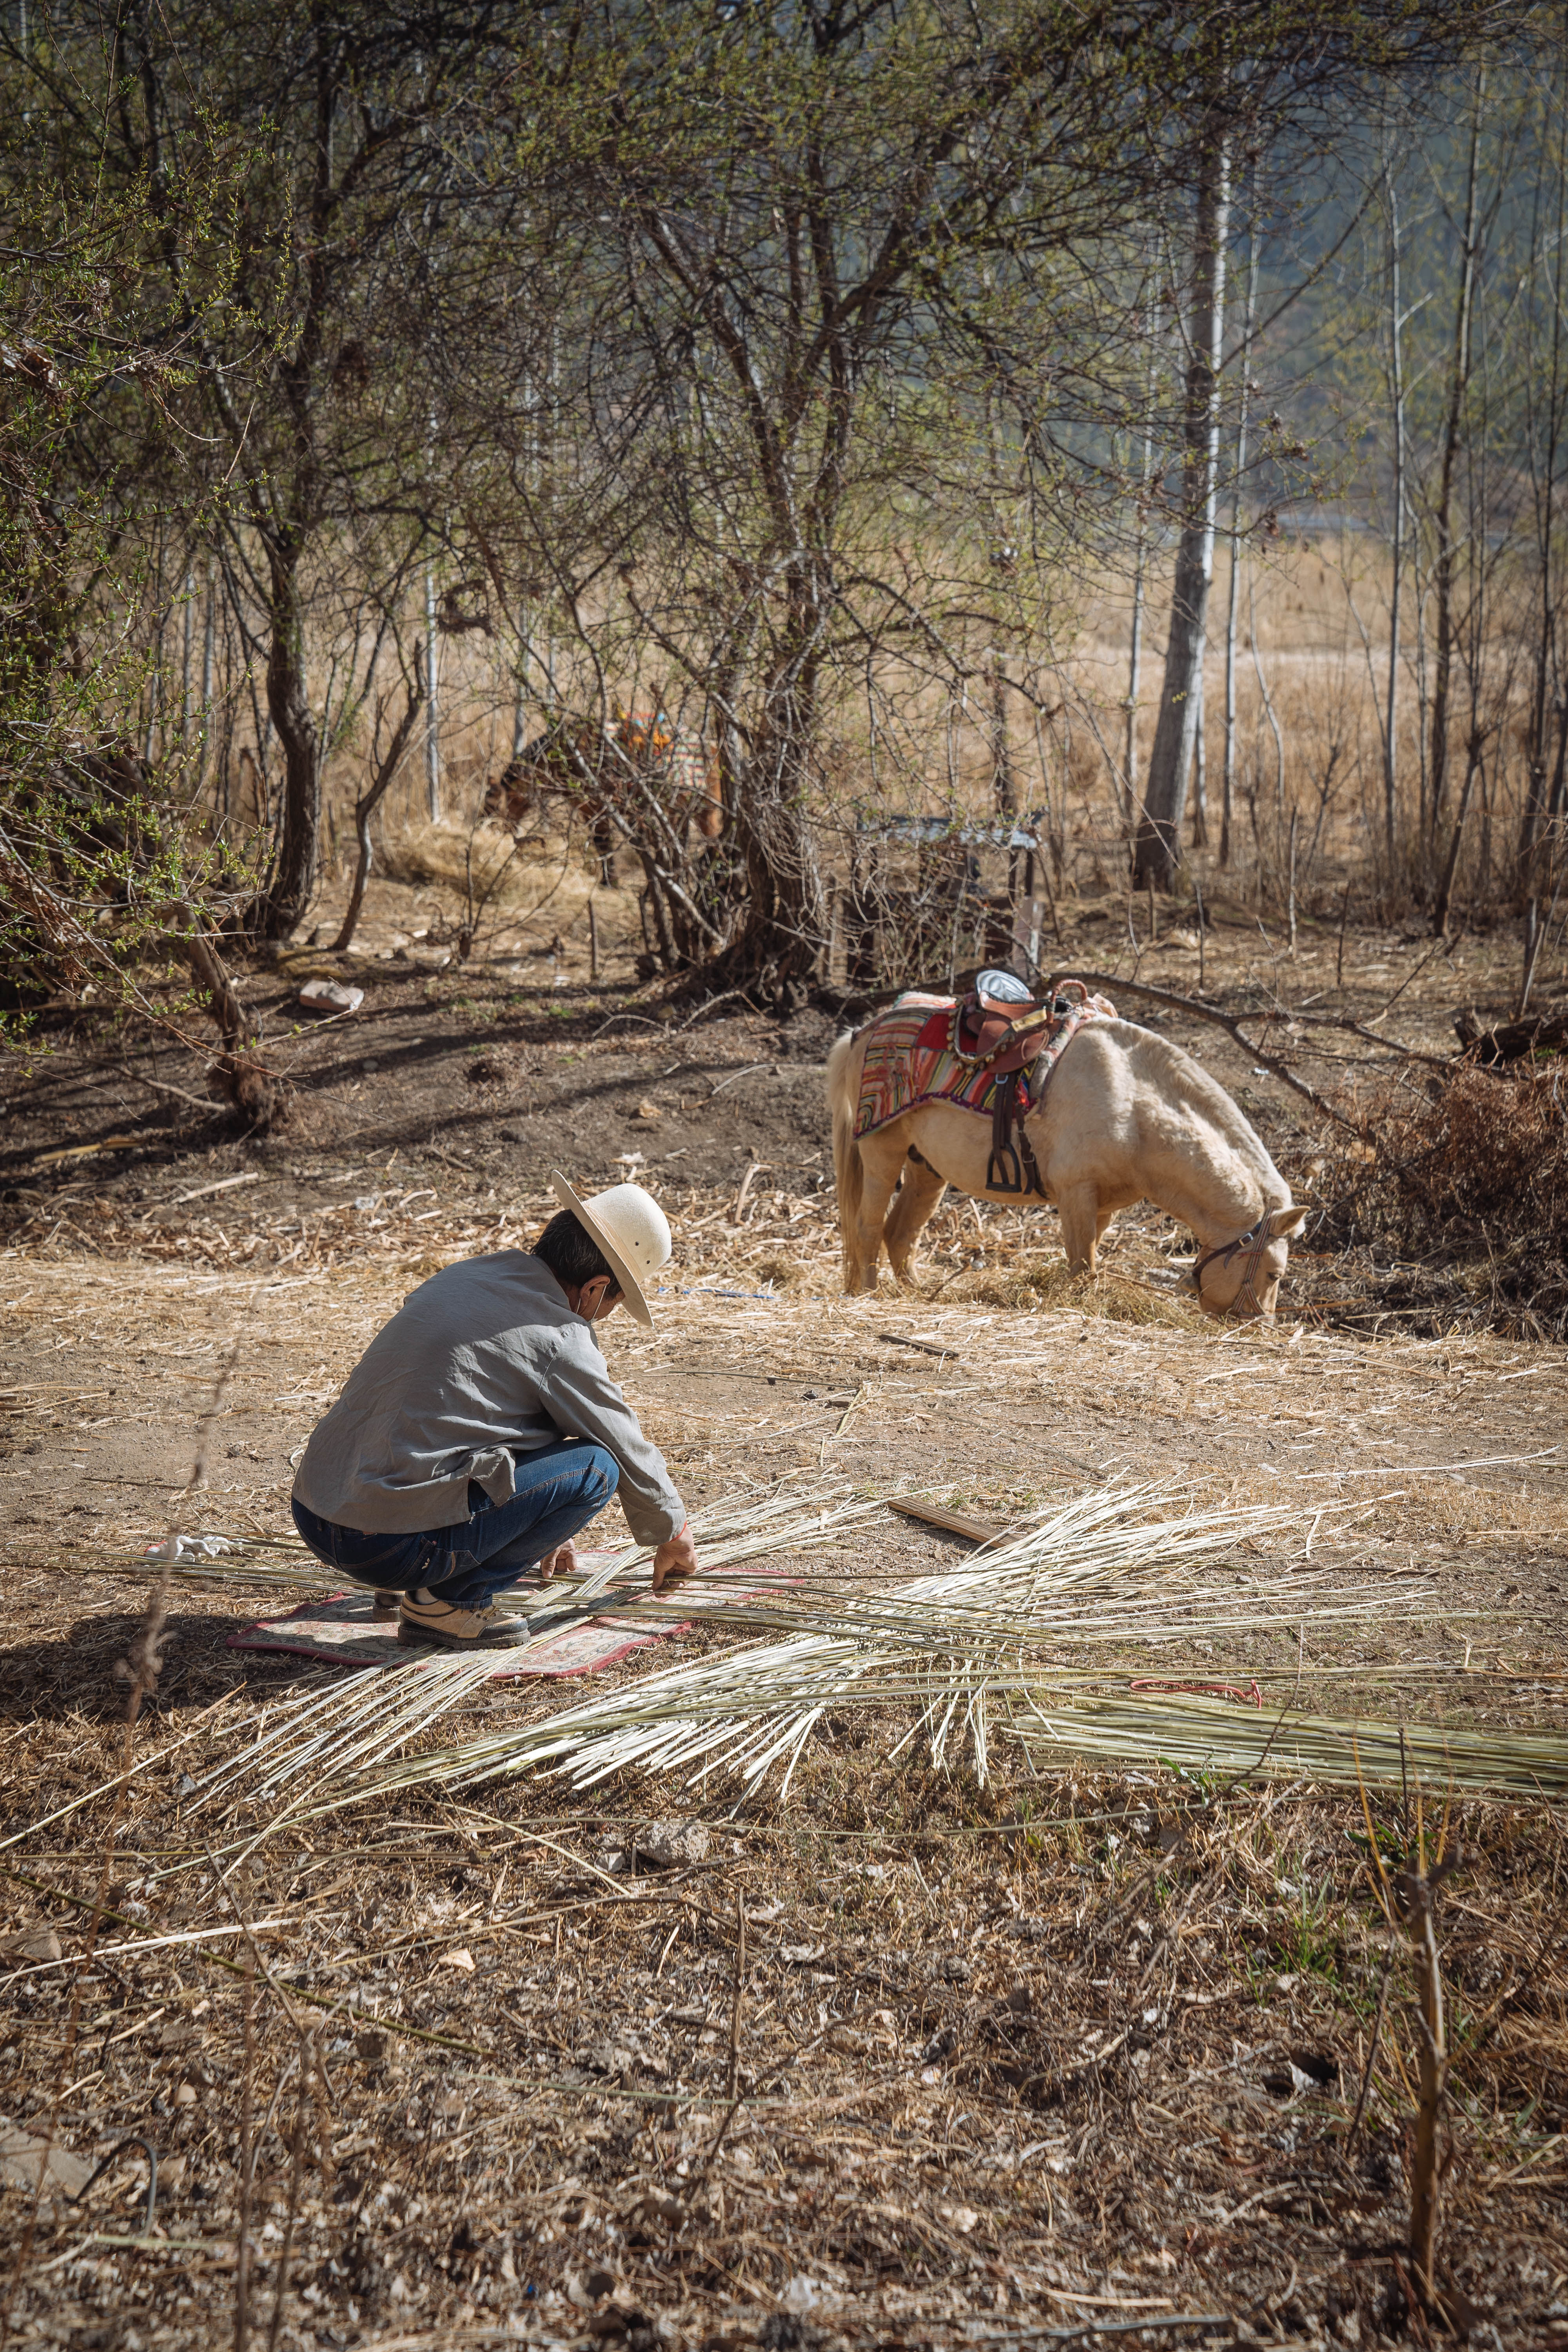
315, 529, 1563, 950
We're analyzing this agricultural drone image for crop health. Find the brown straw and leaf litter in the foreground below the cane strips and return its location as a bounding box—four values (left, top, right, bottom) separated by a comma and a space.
0, 1724, 1568, 2352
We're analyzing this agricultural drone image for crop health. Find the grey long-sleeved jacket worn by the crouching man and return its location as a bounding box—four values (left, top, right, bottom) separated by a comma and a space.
294, 1249, 686, 1543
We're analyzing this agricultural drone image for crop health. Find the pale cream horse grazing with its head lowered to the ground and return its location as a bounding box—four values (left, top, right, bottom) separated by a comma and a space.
828, 1021, 1307, 1317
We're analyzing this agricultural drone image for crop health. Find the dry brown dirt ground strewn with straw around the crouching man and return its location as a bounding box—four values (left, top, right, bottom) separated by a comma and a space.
0, 891, 1568, 2352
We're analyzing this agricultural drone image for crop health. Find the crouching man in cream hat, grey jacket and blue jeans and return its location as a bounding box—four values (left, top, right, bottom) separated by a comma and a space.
294, 1176, 696, 1649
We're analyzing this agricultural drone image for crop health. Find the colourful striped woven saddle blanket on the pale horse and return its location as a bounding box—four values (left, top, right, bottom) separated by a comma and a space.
856, 981, 1117, 1136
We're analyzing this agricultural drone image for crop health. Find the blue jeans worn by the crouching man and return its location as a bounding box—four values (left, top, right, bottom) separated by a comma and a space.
294, 1437, 621, 1609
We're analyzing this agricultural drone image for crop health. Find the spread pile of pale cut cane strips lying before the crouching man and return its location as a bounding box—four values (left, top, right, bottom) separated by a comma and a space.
162, 1486, 1568, 1835
